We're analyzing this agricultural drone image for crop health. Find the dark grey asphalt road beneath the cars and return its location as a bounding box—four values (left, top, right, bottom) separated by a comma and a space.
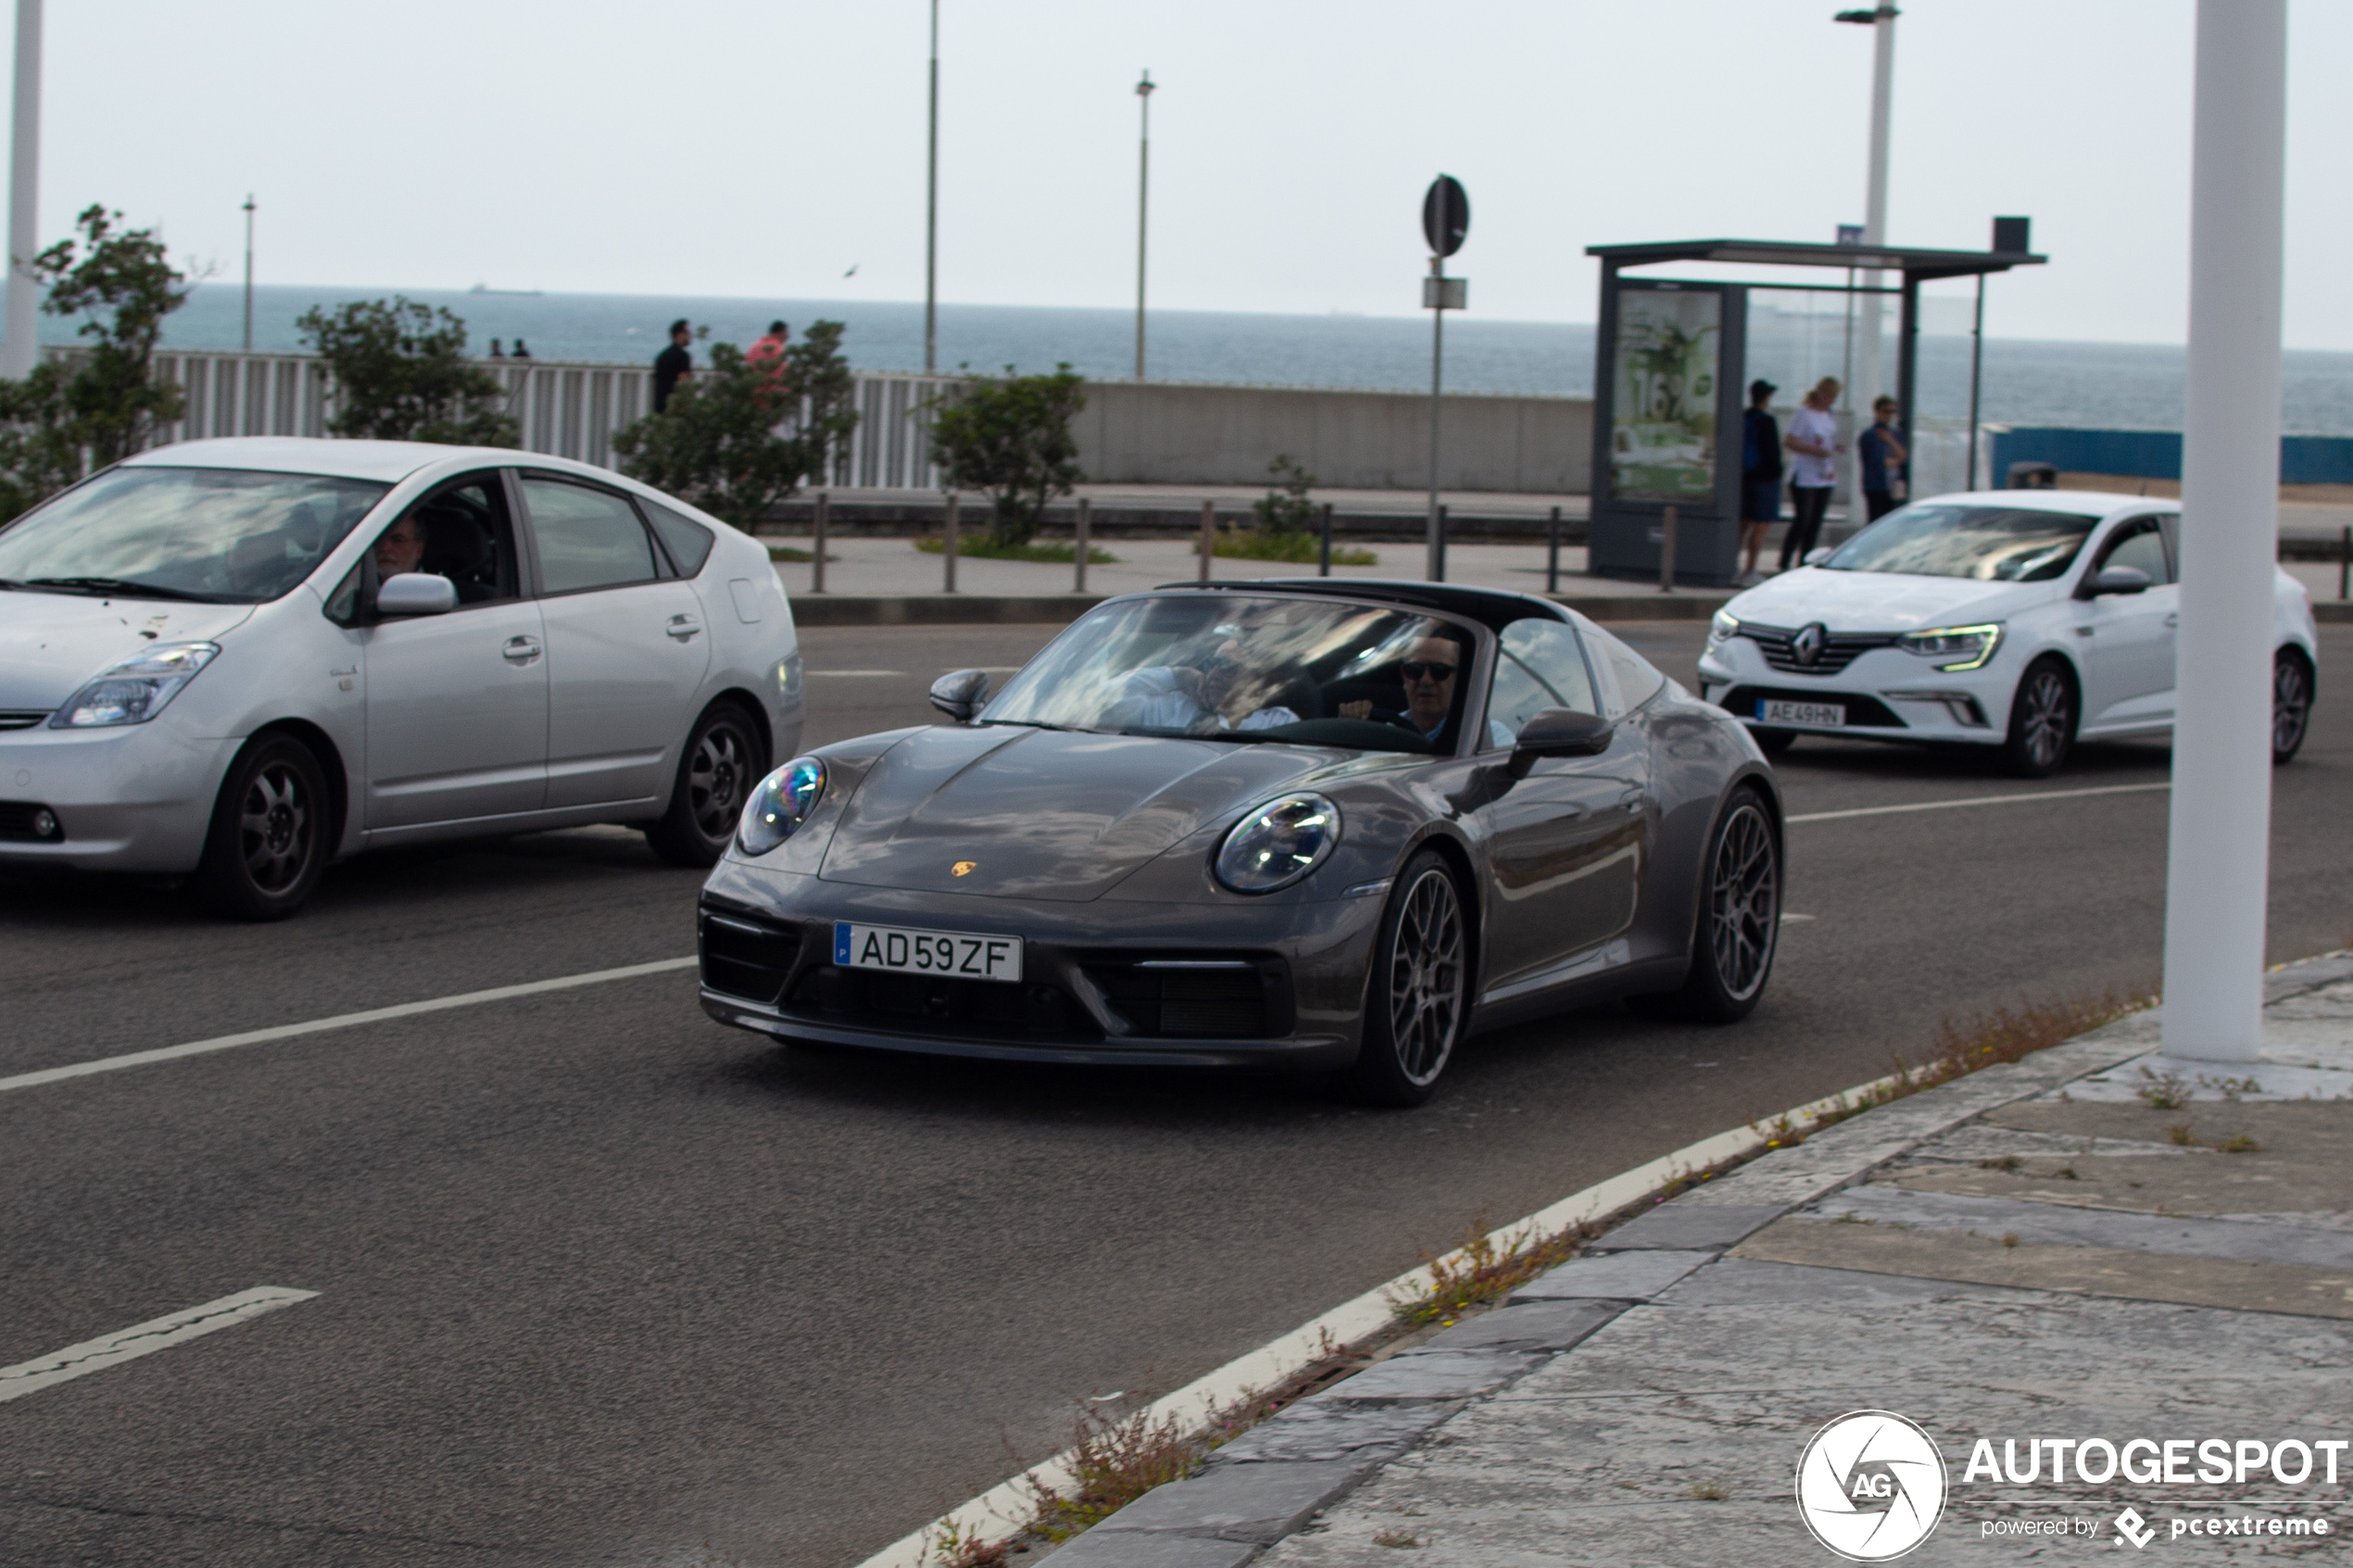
0, 625, 2353, 1568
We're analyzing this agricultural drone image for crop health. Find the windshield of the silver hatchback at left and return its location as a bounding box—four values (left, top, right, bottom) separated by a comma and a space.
0, 466, 391, 604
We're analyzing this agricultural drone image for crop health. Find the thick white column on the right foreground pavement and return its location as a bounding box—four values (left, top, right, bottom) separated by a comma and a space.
2165, 0, 2287, 1062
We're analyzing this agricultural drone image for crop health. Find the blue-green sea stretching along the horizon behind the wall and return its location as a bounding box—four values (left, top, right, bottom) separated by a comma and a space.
101, 280, 2353, 435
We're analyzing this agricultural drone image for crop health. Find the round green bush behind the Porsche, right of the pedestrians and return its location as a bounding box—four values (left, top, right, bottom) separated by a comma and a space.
927, 364, 1087, 547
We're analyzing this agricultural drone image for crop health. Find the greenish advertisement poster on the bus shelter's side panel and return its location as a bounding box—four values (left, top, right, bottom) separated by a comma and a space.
1609, 289, 1725, 503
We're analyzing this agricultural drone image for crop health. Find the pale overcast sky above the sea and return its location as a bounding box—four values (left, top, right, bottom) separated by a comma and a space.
40, 0, 2353, 348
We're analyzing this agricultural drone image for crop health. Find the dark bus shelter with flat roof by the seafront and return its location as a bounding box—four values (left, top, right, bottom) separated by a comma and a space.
1586, 230, 2045, 585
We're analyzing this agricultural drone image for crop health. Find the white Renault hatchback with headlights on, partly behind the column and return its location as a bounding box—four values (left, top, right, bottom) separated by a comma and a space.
1699, 489, 2315, 778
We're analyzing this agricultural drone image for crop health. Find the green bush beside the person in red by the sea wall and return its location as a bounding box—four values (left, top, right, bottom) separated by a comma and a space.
611, 322, 859, 529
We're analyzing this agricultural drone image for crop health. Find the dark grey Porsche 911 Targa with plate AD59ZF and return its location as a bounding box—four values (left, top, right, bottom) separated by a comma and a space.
698, 578, 1781, 1105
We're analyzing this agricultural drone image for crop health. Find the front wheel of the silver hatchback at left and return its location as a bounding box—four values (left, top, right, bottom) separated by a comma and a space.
195, 734, 334, 919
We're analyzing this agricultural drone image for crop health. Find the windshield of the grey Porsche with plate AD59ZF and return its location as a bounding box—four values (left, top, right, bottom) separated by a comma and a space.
979, 593, 1471, 752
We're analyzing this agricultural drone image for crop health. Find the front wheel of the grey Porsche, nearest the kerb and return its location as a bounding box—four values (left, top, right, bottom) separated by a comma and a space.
1346, 848, 1471, 1110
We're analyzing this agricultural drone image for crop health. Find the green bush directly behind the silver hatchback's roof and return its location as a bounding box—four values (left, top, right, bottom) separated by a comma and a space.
295, 294, 522, 446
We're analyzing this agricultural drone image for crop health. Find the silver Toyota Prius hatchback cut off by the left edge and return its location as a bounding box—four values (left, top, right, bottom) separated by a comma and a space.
0, 437, 802, 919
